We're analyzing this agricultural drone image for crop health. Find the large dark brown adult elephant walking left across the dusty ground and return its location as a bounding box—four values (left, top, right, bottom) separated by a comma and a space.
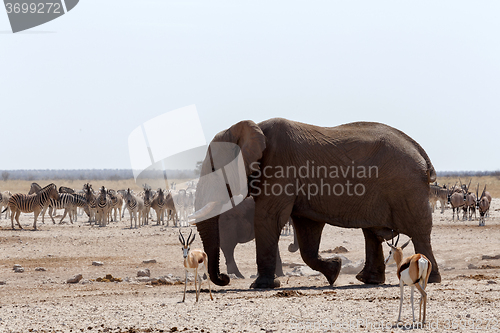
191, 118, 441, 288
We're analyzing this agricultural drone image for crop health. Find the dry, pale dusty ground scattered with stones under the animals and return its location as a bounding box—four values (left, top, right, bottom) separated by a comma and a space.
0, 199, 500, 332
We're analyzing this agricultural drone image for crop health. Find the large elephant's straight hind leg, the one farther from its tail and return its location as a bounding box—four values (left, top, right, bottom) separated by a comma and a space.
356, 229, 385, 284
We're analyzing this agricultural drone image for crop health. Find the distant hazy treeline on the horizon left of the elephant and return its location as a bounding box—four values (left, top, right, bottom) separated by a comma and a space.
0, 169, 196, 181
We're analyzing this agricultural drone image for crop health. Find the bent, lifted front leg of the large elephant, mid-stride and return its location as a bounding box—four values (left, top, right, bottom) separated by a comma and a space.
293, 216, 342, 285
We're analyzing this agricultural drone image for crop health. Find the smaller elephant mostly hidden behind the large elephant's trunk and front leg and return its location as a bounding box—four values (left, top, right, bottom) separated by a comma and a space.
219, 197, 284, 279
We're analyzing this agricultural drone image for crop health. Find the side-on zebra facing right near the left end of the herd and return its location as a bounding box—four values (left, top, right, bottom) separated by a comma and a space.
2, 184, 59, 230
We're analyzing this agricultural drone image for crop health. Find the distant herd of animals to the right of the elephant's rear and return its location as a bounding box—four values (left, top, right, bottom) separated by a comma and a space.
429, 181, 492, 226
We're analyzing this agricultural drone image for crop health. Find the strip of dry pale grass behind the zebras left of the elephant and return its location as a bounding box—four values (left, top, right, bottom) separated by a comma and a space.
0, 178, 193, 193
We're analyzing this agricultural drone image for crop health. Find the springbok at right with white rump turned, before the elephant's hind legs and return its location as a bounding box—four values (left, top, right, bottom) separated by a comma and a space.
385, 235, 432, 323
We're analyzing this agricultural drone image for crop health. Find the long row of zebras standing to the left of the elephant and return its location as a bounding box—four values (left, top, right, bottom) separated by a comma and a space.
0, 183, 196, 230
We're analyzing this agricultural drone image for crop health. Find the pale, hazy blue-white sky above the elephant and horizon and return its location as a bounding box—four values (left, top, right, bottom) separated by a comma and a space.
0, 0, 500, 171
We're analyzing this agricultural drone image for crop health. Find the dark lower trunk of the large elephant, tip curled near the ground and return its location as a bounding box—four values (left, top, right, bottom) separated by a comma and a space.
196, 216, 230, 286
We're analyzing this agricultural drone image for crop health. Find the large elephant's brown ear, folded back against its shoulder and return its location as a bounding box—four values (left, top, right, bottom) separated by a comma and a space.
226, 120, 266, 176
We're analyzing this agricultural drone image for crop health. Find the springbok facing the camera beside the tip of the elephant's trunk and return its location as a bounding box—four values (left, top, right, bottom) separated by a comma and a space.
179, 229, 214, 302
